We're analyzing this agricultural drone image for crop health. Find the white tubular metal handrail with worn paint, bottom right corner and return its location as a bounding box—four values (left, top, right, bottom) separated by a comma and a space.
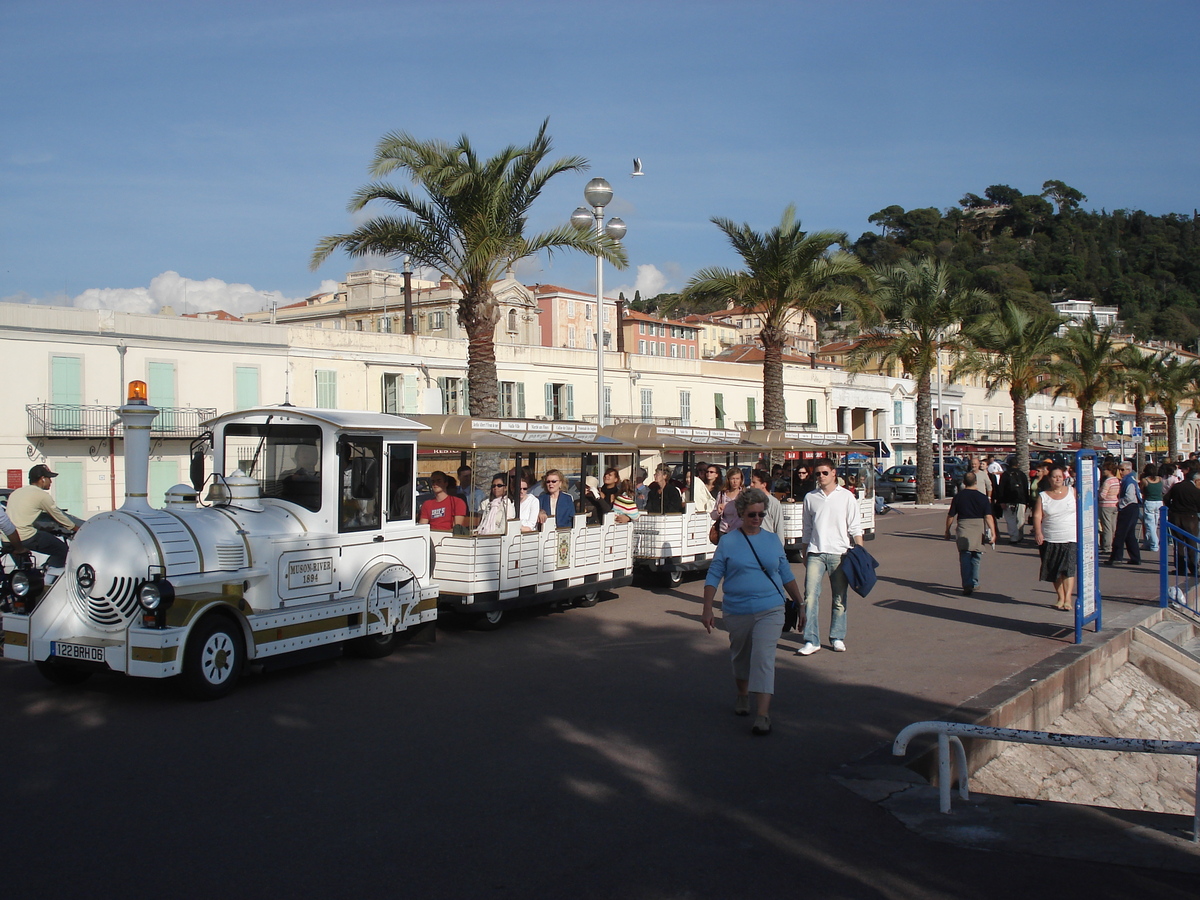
892, 722, 1200, 844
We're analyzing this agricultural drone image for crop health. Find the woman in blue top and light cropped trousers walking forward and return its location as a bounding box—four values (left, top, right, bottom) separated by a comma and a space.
700, 487, 803, 734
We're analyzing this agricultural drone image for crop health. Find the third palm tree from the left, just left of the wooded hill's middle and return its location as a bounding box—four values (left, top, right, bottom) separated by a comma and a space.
851, 257, 991, 503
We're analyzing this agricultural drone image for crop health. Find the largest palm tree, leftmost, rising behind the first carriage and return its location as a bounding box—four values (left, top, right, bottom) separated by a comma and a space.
312, 120, 625, 416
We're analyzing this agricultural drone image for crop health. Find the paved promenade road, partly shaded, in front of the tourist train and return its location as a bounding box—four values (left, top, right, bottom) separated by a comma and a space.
0, 510, 1196, 900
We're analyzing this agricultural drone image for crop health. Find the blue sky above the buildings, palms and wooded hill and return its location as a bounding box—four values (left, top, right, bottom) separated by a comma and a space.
0, 0, 1200, 312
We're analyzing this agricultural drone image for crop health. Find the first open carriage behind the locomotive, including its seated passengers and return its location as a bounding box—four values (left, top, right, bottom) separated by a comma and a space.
414, 415, 637, 629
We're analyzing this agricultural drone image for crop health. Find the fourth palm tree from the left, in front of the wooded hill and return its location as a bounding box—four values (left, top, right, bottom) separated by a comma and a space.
954, 301, 1063, 472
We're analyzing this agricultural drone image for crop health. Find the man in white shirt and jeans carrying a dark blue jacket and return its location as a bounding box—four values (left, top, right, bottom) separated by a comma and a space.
796, 460, 863, 656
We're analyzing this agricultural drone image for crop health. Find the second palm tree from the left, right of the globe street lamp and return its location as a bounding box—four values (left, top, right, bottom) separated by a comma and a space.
680, 205, 870, 428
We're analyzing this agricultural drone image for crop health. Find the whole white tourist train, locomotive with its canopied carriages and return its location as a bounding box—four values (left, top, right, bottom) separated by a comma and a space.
2, 382, 883, 698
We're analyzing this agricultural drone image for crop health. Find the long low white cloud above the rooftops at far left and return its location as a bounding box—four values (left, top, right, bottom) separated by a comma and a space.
2, 271, 314, 316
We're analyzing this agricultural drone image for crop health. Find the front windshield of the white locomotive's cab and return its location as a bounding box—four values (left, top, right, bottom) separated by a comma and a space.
224, 422, 322, 512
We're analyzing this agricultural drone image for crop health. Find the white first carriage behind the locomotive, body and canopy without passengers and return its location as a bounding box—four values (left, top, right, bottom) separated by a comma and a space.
414, 415, 635, 629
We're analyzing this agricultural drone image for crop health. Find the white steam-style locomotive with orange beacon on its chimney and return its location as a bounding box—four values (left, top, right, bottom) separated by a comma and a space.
4, 382, 439, 698
